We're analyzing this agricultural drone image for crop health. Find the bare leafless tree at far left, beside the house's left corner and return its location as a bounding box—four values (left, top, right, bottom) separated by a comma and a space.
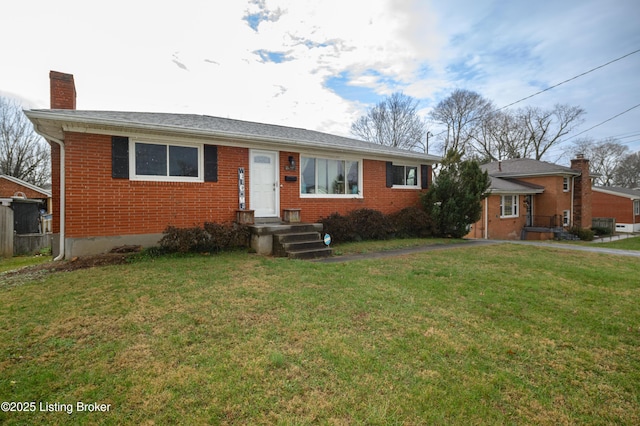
0, 97, 50, 186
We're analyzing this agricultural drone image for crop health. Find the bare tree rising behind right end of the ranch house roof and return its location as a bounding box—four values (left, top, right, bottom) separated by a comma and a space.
351, 92, 425, 151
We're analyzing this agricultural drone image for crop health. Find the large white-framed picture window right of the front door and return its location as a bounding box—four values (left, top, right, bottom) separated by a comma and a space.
300, 156, 361, 197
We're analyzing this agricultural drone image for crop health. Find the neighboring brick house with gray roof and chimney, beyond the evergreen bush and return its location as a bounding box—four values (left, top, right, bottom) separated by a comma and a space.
467, 156, 591, 240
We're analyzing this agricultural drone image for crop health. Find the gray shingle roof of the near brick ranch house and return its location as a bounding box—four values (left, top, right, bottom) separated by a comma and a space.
25, 109, 440, 162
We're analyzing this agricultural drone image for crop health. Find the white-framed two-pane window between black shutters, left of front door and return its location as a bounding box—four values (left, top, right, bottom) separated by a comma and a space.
130, 141, 203, 182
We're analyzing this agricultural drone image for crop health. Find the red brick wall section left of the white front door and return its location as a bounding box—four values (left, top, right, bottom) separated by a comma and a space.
65, 133, 249, 238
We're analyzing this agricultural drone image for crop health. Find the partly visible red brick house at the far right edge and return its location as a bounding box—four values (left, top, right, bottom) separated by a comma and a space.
592, 186, 640, 232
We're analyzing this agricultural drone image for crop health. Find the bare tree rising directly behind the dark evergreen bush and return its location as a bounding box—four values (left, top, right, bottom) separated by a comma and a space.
430, 89, 494, 156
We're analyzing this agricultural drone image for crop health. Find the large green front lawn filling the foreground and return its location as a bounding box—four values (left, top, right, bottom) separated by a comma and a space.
0, 244, 640, 425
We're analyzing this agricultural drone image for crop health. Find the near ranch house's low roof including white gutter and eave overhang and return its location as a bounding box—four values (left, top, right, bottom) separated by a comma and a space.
25, 109, 441, 163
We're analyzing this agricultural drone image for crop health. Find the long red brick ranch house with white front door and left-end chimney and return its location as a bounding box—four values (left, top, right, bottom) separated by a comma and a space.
25, 71, 440, 259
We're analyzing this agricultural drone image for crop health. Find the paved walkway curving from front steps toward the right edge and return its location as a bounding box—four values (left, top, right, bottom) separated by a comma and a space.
314, 240, 640, 263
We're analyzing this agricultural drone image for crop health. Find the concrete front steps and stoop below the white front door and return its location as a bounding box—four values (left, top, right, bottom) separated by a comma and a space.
251, 223, 331, 259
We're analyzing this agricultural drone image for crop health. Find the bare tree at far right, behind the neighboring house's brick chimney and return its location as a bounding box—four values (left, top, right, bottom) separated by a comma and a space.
571, 138, 629, 186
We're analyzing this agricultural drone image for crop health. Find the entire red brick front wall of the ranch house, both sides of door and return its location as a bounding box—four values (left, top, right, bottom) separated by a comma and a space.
60, 140, 428, 238
